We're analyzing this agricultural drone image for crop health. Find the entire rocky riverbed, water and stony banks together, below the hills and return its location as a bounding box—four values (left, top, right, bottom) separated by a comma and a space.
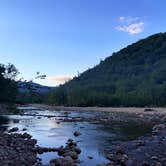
0, 105, 166, 166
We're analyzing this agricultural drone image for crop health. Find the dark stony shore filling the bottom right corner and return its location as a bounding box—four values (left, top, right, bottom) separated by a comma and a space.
98, 124, 166, 166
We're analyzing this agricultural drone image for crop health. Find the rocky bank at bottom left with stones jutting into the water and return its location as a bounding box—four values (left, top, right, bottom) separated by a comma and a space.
0, 127, 81, 166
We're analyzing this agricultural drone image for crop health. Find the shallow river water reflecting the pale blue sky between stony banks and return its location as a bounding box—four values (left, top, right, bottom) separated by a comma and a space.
0, 107, 150, 166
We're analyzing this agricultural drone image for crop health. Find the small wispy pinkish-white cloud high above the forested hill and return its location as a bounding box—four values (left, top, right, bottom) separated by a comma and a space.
116, 16, 145, 35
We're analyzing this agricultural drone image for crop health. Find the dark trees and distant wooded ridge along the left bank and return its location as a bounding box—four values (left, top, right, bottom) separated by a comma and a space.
0, 64, 49, 104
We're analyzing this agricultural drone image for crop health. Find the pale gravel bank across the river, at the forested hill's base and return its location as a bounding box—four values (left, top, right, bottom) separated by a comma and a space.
28, 104, 166, 125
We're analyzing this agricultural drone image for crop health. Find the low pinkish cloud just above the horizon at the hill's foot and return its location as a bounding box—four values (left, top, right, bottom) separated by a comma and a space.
47, 75, 74, 85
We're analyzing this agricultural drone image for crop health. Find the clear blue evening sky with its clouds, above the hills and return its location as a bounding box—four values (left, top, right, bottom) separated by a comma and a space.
0, 0, 166, 86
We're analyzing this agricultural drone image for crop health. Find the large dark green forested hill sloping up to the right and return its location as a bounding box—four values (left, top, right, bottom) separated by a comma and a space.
49, 33, 166, 106
